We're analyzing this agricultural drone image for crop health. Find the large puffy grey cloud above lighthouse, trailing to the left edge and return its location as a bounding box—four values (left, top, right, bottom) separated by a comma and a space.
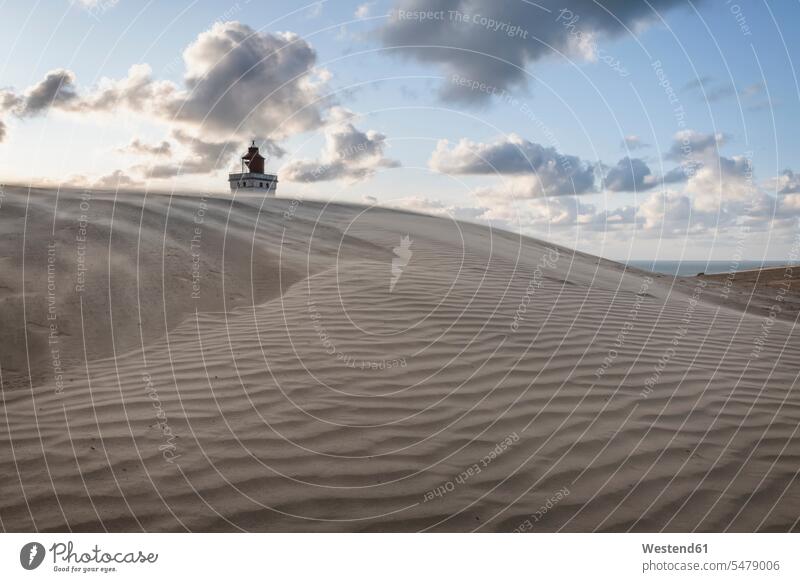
0, 22, 331, 153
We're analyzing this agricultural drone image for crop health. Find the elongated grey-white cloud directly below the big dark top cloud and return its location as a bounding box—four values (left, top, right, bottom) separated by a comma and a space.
428, 134, 595, 198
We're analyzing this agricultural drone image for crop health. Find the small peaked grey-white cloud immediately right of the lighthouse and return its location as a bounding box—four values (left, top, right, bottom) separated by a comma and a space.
281, 107, 399, 182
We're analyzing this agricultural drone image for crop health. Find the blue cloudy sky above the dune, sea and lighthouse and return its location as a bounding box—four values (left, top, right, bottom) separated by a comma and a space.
0, 0, 800, 261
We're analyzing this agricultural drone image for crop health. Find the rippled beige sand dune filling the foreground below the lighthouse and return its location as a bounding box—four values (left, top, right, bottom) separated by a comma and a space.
0, 188, 800, 531
